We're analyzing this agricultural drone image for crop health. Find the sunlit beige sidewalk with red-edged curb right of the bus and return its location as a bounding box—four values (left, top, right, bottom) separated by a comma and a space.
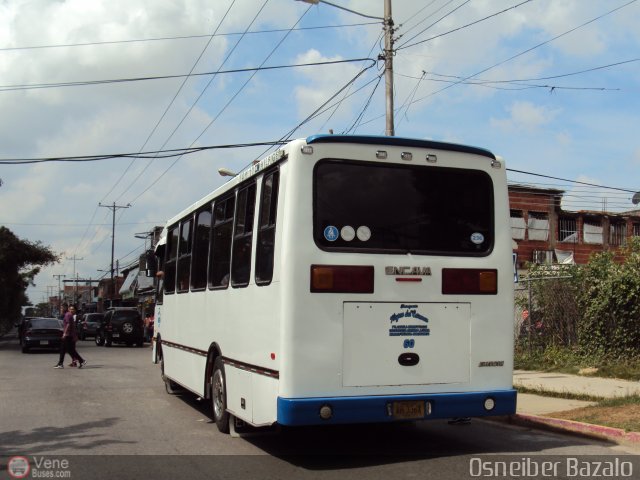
510, 370, 640, 446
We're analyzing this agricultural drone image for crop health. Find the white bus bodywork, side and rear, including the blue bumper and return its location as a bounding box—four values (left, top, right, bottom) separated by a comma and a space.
158, 137, 516, 425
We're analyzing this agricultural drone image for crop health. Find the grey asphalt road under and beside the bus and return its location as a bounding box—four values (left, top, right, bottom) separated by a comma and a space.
0, 338, 640, 480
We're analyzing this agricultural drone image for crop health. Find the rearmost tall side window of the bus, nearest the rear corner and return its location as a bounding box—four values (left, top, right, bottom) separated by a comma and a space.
256, 170, 280, 285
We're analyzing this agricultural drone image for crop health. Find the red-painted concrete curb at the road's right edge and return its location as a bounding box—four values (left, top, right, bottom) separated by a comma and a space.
508, 413, 640, 445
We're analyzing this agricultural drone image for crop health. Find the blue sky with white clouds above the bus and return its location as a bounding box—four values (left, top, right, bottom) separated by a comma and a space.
0, 0, 640, 303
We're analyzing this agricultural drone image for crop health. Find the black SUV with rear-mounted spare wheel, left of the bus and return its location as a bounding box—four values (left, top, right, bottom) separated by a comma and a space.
96, 307, 144, 347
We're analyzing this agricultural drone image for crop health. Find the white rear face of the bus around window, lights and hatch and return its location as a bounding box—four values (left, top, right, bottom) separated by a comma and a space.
280, 138, 513, 399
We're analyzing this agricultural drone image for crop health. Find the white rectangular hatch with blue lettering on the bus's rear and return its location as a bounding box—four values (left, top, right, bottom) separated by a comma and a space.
342, 302, 470, 387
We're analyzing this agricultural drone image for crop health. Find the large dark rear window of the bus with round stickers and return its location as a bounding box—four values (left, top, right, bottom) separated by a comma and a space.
313, 159, 494, 256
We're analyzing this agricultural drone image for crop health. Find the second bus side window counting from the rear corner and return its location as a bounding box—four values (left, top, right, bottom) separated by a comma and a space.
231, 183, 256, 287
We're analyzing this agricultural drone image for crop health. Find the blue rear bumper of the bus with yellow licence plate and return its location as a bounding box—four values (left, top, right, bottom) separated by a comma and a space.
278, 389, 516, 426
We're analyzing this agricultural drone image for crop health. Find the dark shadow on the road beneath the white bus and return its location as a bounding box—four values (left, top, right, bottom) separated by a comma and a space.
162, 390, 613, 470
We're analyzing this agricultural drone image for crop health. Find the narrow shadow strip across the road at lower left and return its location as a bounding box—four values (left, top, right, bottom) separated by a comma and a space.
0, 418, 135, 456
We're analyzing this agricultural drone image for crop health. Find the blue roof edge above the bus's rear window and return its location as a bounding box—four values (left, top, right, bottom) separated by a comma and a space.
306, 135, 496, 160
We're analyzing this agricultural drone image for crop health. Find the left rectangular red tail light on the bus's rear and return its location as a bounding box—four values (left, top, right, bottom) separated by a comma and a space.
311, 265, 373, 293
